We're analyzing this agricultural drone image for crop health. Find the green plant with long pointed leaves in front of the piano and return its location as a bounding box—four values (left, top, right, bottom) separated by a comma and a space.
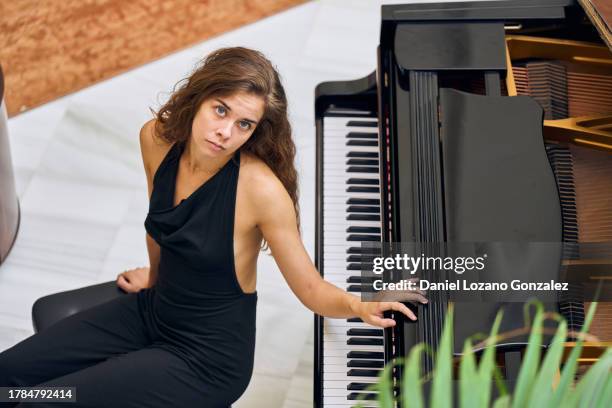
360, 302, 612, 408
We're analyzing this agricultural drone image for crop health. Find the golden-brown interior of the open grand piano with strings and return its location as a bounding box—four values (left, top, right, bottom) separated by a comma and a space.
505, 35, 612, 348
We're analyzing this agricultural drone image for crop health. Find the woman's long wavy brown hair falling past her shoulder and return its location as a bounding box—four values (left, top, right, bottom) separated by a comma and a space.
154, 47, 300, 249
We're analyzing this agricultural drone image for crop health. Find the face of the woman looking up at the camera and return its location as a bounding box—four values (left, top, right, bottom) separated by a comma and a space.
191, 92, 264, 158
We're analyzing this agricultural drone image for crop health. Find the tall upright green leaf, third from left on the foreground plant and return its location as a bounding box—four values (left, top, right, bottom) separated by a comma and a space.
431, 304, 453, 408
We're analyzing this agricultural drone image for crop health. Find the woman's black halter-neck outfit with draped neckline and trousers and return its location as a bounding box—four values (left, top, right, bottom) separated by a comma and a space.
0, 144, 257, 408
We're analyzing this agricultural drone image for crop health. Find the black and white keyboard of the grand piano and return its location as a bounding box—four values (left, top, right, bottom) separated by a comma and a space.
322, 112, 384, 408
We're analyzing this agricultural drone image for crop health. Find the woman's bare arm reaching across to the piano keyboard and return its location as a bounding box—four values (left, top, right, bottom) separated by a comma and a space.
253, 172, 427, 327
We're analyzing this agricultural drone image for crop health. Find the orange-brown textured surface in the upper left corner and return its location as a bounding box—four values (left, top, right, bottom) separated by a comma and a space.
0, 0, 305, 116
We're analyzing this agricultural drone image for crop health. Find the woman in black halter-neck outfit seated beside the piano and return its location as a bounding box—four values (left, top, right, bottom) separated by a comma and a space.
0, 48, 425, 407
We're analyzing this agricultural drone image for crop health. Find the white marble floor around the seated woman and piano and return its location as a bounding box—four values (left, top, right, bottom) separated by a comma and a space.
0, 0, 474, 408
